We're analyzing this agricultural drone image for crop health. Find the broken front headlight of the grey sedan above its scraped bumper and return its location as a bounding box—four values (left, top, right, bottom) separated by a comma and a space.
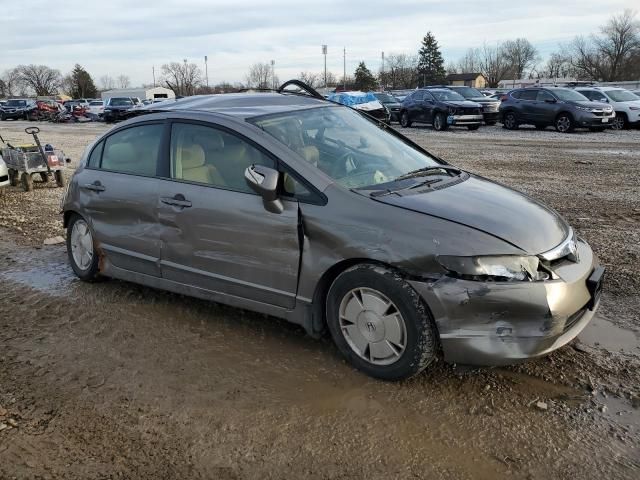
437, 255, 549, 282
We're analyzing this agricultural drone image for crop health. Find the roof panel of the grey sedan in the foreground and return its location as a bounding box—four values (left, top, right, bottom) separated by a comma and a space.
146, 93, 333, 118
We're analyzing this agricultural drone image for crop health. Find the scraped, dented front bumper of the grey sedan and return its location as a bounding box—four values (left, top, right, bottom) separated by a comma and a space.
410, 239, 603, 366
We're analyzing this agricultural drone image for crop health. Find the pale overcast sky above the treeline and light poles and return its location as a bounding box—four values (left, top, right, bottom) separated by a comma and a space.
0, 0, 639, 86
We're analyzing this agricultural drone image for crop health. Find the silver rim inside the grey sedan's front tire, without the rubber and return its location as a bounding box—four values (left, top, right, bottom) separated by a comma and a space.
339, 288, 407, 365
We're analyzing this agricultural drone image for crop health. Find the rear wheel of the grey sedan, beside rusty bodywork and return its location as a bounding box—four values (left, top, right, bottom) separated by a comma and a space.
67, 214, 100, 282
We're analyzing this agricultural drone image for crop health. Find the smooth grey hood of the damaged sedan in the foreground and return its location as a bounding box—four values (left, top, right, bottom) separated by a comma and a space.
376, 175, 569, 254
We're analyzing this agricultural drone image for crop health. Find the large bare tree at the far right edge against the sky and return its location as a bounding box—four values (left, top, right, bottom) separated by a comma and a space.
570, 10, 640, 82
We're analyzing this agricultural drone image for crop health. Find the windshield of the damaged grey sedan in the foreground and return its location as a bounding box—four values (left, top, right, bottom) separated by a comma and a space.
249, 107, 440, 188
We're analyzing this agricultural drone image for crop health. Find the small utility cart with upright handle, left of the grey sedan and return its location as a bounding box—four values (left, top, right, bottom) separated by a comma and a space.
2, 127, 66, 192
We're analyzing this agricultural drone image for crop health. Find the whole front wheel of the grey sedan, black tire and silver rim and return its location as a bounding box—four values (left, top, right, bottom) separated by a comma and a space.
326, 264, 438, 380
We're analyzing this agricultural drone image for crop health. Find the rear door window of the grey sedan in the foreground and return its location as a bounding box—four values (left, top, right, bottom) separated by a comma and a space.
100, 124, 164, 177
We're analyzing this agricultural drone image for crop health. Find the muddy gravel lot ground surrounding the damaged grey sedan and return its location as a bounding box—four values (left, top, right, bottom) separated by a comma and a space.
0, 122, 640, 479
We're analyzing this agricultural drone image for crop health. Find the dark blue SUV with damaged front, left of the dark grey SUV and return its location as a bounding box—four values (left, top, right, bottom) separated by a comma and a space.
400, 87, 483, 131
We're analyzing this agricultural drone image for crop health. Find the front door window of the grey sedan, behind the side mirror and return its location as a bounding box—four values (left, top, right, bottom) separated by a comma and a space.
171, 123, 275, 193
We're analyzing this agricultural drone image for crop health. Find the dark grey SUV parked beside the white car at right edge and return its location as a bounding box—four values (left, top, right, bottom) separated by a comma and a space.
500, 87, 615, 133
